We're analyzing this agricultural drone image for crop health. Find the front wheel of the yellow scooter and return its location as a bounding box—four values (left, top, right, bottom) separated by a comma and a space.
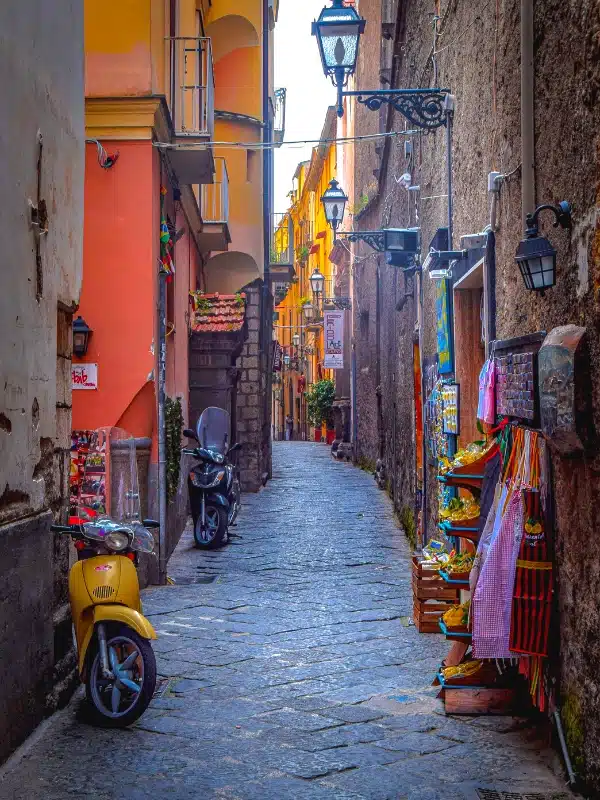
85, 625, 156, 728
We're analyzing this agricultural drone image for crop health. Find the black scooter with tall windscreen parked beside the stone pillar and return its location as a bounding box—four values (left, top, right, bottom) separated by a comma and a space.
183, 407, 241, 550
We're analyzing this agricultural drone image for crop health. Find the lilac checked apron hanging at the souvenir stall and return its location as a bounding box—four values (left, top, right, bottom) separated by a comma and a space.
473, 490, 523, 658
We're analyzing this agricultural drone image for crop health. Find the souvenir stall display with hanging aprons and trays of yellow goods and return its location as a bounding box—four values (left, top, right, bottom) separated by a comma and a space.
413, 335, 554, 714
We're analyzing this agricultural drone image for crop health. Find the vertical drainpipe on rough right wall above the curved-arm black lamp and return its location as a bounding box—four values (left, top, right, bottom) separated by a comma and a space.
521, 0, 535, 228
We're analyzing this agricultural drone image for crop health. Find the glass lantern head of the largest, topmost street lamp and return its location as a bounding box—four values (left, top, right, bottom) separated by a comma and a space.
312, 0, 365, 80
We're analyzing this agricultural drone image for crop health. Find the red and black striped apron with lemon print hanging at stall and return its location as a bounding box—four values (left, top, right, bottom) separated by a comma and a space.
510, 490, 554, 656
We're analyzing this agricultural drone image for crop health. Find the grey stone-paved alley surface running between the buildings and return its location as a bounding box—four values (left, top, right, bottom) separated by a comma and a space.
0, 443, 569, 800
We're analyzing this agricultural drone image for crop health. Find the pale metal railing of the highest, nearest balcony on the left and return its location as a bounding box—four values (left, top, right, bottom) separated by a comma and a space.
168, 36, 215, 138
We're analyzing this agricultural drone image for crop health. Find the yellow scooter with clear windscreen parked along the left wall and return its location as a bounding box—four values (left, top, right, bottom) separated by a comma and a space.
51, 428, 159, 728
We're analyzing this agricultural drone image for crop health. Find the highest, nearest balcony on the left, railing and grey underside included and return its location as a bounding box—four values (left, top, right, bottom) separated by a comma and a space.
168, 36, 215, 184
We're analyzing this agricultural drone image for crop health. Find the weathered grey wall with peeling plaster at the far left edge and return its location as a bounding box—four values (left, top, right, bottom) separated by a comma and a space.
0, 0, 84, 759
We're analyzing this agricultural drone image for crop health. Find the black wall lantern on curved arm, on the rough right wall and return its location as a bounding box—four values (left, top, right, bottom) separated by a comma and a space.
516, 200, 571, 294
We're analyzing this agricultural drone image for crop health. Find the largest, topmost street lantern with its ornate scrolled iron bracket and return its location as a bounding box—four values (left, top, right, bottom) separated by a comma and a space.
312, 0, 449, 125
